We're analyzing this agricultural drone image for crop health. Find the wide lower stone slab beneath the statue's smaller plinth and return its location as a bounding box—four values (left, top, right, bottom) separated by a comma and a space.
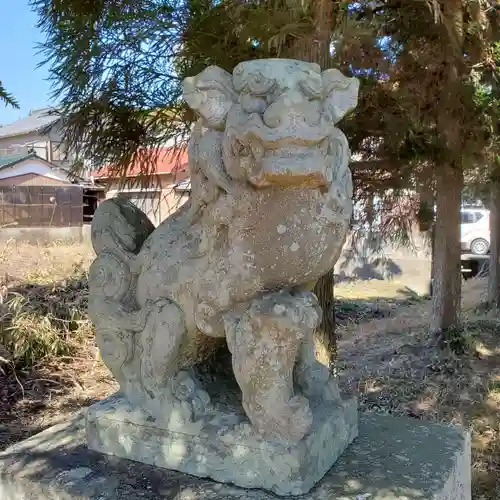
0, 414, 471, 500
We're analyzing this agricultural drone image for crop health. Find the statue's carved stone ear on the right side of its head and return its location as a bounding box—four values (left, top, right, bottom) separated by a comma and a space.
322, 69, 359, 124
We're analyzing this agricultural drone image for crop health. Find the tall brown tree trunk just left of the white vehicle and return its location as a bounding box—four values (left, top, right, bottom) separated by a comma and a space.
431, 0, 465, 336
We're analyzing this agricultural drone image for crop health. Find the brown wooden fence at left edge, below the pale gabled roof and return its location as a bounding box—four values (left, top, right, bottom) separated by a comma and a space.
0, 185, 83, 227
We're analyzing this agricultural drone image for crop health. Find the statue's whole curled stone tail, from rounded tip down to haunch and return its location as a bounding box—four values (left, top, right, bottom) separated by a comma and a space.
88, 198, 154, 396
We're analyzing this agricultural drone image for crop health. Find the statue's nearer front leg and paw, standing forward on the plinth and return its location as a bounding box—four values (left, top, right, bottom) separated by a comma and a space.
227, 293, 320, 442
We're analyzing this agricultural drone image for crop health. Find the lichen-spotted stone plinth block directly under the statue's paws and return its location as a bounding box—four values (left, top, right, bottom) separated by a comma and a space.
87, 395, 358, 495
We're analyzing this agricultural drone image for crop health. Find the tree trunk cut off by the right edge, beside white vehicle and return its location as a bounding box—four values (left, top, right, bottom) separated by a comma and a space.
488, 182, 500, 310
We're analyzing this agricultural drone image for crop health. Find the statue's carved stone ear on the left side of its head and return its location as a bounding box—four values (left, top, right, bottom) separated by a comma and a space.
183, 66, 237, 130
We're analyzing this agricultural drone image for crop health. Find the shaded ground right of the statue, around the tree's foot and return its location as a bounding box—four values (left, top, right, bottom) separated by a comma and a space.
339, 311, 500, 500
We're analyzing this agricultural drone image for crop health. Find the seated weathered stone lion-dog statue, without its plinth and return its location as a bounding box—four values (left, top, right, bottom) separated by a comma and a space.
89, 59, 359, 442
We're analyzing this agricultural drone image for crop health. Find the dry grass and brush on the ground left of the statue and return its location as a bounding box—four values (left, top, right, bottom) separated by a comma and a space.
0, 242, 116, 449
